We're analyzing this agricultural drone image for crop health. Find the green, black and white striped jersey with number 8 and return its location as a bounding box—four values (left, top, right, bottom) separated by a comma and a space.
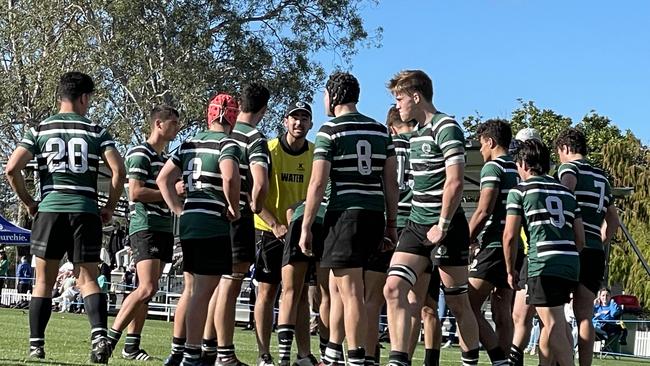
314, 113, 395, 212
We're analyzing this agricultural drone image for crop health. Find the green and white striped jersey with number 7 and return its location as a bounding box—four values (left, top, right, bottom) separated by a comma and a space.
558, 159, 612, 250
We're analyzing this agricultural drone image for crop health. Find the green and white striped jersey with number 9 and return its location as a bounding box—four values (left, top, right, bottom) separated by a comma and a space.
506, 175, 580, 281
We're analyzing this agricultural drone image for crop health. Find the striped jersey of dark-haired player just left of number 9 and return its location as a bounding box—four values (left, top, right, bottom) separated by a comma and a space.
481, 155, 519, 249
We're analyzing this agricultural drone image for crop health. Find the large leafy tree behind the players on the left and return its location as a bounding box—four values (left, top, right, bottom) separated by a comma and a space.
0, 0, 381, 220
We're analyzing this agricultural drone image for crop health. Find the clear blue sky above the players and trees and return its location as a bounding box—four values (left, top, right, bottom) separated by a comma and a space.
310, 0, 650, 144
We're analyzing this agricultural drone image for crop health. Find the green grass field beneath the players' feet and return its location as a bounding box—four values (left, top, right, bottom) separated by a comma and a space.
0, 309, 650, 366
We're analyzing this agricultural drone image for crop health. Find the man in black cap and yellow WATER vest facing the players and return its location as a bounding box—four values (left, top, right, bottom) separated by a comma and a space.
254, 102, 314, 366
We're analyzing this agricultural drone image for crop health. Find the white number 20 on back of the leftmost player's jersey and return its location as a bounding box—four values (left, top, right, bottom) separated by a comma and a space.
43, 137, 88, 173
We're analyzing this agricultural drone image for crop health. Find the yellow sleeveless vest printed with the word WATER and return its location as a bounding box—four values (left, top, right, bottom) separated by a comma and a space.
255, 134, 314, 231
